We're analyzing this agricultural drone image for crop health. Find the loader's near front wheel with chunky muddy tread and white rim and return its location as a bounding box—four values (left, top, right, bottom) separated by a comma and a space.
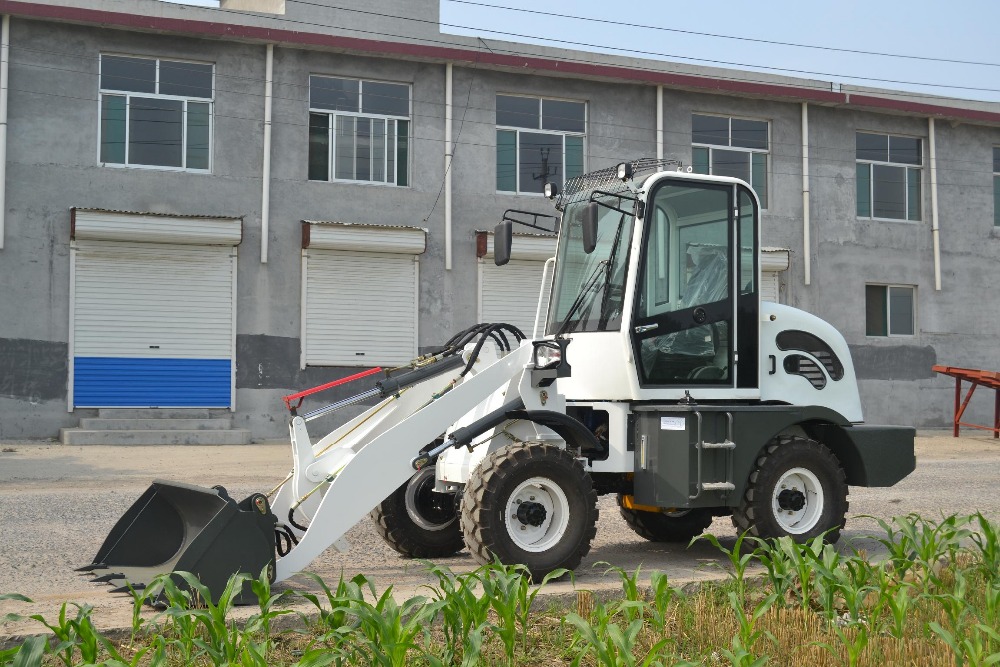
461, 443, 598, 581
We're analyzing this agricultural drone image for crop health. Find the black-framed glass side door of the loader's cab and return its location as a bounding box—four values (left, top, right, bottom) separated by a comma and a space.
631, 179, 736, 388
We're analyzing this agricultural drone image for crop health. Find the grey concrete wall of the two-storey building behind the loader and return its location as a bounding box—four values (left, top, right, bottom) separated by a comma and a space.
0, 11, 1000, 438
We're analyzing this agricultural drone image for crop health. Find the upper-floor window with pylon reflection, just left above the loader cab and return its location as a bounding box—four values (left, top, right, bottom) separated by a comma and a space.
497, 95, 587, 194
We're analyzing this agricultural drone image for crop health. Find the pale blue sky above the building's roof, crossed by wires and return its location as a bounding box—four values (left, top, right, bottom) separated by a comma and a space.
160, 0, 1000, 102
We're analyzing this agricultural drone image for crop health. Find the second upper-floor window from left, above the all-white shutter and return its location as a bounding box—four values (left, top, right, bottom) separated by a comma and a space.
309, 75, 411, 186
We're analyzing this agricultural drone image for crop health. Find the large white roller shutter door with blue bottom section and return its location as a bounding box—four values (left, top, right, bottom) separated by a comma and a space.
71, 241, 236, 407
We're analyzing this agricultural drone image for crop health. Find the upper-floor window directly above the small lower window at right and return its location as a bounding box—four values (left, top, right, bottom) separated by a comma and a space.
857, 132, 923, 221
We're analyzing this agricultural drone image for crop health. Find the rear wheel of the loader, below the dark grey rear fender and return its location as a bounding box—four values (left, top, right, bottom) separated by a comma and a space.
733, 436, 848, 544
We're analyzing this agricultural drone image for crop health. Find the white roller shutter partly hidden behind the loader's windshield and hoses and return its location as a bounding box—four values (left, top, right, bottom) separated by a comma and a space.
479, 259, 551, 338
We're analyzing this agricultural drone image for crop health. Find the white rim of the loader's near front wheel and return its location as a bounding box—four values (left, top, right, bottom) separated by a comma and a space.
504, 477, 569, 553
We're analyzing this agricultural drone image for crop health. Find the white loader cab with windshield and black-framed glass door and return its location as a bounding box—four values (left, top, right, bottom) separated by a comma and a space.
546, 167, 760, 400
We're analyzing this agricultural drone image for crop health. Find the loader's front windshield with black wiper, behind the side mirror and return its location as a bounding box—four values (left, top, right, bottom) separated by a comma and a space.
546, 197, 633, 335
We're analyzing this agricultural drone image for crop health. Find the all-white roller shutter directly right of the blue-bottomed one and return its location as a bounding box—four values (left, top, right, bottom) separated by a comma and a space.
304, 249, 418, 366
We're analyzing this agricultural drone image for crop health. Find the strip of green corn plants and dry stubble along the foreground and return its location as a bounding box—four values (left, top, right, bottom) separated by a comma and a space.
0, 514, 1000, 667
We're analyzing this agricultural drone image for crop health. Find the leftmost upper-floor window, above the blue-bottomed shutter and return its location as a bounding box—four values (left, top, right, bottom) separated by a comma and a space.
99, 55, 214, 171
